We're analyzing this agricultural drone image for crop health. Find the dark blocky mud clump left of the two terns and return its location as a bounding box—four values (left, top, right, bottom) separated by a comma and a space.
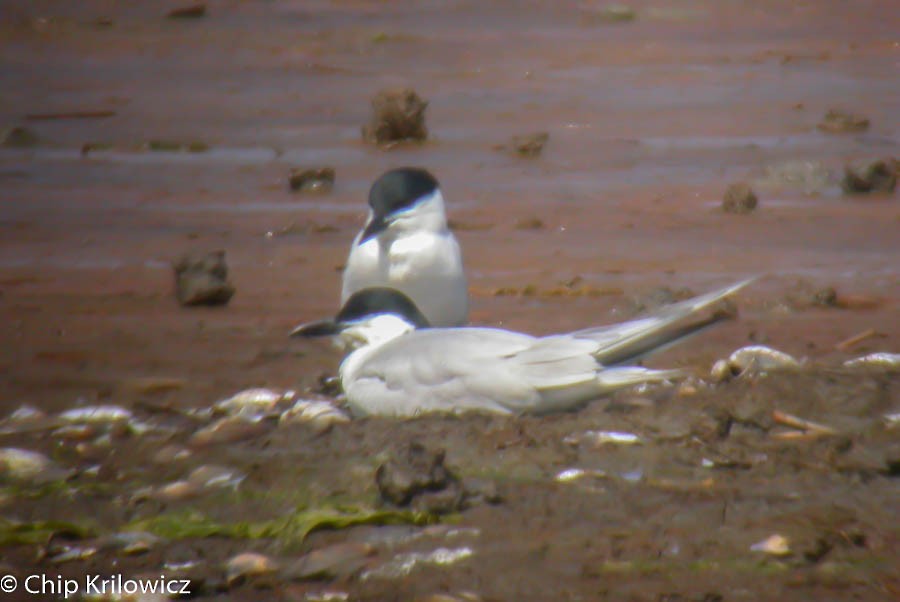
174, 251, 234, 306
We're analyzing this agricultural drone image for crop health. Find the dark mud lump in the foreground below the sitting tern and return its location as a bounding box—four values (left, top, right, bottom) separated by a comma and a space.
375, 441, 465, 514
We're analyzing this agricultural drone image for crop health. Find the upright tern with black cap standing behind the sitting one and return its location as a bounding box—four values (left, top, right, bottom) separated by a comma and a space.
341, 167, 469, 326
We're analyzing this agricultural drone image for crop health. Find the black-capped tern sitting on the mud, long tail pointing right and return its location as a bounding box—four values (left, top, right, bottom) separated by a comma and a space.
291, 280, 752, 417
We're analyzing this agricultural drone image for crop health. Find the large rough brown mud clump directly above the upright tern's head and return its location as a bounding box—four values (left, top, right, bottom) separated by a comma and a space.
362, 88, 428, 146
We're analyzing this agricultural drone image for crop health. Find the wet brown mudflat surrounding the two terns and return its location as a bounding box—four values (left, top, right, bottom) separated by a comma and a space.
0, 0, 900, 601
